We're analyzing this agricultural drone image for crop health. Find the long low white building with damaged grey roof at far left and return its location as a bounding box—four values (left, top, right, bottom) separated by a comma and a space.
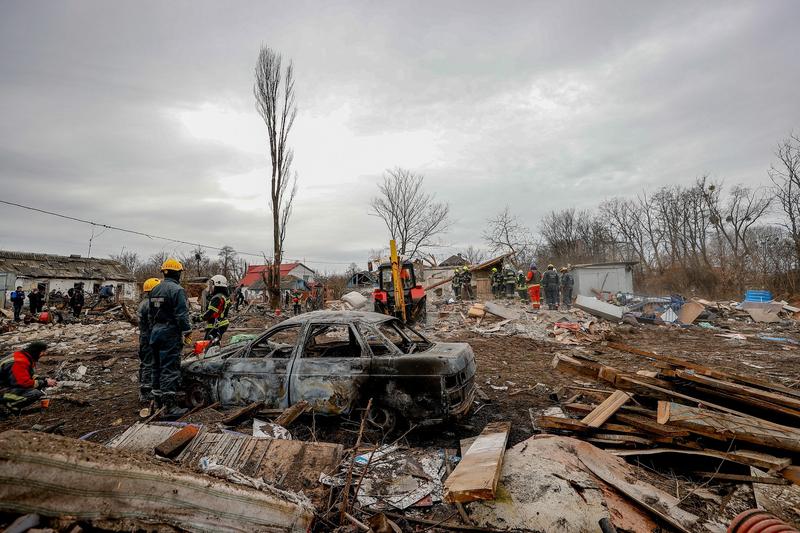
0, 250, 138, 305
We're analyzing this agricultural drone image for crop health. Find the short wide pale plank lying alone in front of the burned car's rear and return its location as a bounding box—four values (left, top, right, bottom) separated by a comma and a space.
444, 422, 511, 503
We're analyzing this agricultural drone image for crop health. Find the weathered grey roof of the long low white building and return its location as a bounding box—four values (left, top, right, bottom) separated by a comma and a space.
0, 250, 134, 281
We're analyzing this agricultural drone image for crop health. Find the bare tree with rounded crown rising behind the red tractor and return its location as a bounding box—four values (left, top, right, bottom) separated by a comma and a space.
370, 168, 450, 259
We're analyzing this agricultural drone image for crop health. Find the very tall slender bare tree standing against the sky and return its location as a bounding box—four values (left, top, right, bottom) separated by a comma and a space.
253, 46, 297, 307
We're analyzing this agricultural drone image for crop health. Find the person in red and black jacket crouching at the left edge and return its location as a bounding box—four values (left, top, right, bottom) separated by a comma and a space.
0, 341, 58, 414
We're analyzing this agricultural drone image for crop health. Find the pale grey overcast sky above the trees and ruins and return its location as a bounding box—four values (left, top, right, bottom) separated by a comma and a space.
0, 0, 800, 271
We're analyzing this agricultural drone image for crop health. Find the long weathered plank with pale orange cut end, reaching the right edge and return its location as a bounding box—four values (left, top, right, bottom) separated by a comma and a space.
658, 401, 800, 452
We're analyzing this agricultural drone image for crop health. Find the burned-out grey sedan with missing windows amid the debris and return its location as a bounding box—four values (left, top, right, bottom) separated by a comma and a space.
182, 311, 476, 428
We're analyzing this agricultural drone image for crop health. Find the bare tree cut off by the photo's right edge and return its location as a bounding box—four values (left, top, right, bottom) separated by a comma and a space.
769, 133, 800, 268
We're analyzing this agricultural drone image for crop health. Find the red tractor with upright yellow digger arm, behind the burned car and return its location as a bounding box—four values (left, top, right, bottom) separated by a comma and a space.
372, 241, 427, 324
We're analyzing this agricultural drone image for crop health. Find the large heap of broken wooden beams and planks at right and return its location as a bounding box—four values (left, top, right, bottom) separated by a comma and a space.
532, 342, 800, 523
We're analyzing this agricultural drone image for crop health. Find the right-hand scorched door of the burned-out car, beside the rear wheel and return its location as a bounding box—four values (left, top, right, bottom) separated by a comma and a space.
289, 322, 370, 415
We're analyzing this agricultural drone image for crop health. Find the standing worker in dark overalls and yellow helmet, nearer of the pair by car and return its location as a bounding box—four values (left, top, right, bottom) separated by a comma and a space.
147, 257, 192, 418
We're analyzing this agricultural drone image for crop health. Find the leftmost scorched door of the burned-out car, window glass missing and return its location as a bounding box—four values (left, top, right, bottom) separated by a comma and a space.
217, 324, 303, 408
